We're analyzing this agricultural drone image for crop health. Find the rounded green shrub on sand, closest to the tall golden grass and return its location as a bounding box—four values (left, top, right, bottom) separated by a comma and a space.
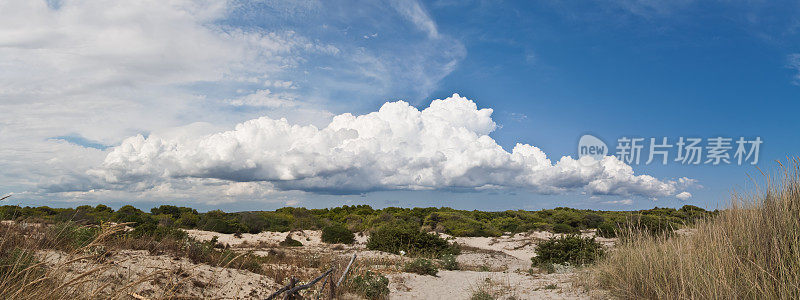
531, 235, 603, 266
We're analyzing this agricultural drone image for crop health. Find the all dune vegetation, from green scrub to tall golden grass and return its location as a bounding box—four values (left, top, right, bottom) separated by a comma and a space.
12, 165, 800, 299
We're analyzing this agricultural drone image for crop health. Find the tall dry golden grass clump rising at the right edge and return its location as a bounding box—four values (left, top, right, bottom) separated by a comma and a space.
589, 163, 800, 299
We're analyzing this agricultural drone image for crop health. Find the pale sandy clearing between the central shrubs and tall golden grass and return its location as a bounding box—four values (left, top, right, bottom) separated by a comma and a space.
382, 231, 614, 299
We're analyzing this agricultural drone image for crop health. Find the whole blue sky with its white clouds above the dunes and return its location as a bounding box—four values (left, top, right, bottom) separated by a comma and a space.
0, 0, 800, 210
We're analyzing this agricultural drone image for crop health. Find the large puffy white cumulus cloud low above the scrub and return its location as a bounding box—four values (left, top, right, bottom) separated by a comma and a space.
89, 94, 681, 197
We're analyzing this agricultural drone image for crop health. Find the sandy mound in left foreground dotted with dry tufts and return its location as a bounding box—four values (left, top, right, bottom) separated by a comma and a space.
38, 250, 279, 299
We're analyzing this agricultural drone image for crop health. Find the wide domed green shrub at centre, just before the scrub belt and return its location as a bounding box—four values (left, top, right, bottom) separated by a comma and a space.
367, 225, 459, 257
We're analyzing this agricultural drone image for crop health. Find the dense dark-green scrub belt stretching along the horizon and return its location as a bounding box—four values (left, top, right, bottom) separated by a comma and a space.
0, 204, 716, 241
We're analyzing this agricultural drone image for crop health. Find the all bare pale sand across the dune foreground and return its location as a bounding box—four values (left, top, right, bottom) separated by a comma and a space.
28, 230, 614, 299
